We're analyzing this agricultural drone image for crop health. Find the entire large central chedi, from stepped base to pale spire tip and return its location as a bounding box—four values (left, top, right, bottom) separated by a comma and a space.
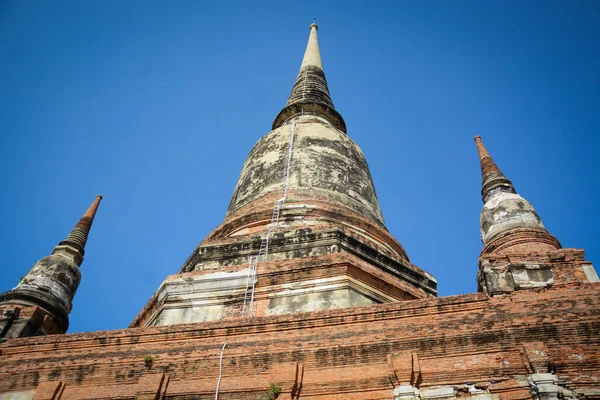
131, 24, 437, 327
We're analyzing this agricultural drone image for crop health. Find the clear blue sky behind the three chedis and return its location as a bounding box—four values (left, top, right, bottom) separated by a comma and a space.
0, 0, 600, 332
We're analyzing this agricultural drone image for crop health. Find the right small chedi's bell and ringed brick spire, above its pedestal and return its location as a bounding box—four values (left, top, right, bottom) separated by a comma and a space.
475, 136, 561, 254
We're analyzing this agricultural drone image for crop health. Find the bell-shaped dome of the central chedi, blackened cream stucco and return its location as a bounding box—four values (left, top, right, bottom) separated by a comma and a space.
227, 116, 384, 225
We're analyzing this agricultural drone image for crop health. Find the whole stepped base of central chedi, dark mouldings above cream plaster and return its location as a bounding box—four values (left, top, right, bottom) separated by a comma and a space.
131, 226, 436, 327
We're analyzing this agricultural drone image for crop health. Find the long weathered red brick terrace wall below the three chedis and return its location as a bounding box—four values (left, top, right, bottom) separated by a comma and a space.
0, 276, 600, 399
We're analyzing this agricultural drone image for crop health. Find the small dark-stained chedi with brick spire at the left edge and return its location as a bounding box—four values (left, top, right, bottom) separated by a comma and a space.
0, 196, 102, 337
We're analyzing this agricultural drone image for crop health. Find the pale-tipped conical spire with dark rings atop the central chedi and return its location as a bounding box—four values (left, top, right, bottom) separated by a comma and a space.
273, 22, 346, 133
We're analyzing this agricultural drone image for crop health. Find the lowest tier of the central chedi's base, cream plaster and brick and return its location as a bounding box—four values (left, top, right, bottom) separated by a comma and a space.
131, 253, 426, 327
